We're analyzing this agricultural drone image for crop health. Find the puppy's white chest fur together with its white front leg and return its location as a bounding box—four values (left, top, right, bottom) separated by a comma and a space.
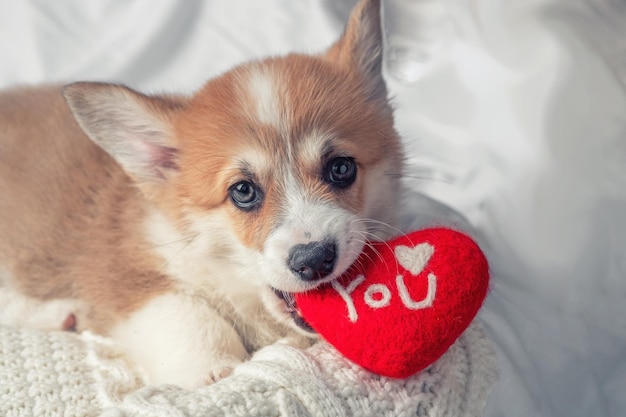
111, 209, 298, 388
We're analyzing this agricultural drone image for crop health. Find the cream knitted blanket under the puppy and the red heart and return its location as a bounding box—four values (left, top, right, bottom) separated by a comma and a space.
0, 323, 496, 417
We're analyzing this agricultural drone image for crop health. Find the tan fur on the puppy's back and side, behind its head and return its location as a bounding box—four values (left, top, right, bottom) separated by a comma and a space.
0, 87, 170, 333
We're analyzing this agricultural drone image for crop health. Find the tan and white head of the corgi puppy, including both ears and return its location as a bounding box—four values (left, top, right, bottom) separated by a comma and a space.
64, 0, 402, 332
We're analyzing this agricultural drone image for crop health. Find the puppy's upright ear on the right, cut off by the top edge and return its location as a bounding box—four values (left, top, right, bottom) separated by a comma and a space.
326, 0, 387, 102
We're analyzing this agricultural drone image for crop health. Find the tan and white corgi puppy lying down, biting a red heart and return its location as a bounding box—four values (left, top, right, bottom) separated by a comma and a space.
0, 0, 403, 388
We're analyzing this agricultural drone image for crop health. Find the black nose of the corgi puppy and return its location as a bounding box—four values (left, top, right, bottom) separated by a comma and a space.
287, 241, 336, 281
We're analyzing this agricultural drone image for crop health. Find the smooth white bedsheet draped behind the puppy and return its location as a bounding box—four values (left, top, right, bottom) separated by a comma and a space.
0, 0, 626, 417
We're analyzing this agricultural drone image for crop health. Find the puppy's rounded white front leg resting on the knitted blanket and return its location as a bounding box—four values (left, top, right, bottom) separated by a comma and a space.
111, 293, 248, 388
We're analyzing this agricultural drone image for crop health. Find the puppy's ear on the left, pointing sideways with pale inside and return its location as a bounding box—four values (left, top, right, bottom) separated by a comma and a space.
63, 83, 180, 185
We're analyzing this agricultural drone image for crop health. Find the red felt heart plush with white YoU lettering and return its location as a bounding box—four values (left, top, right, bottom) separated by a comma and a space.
296, 228, 489, 378
